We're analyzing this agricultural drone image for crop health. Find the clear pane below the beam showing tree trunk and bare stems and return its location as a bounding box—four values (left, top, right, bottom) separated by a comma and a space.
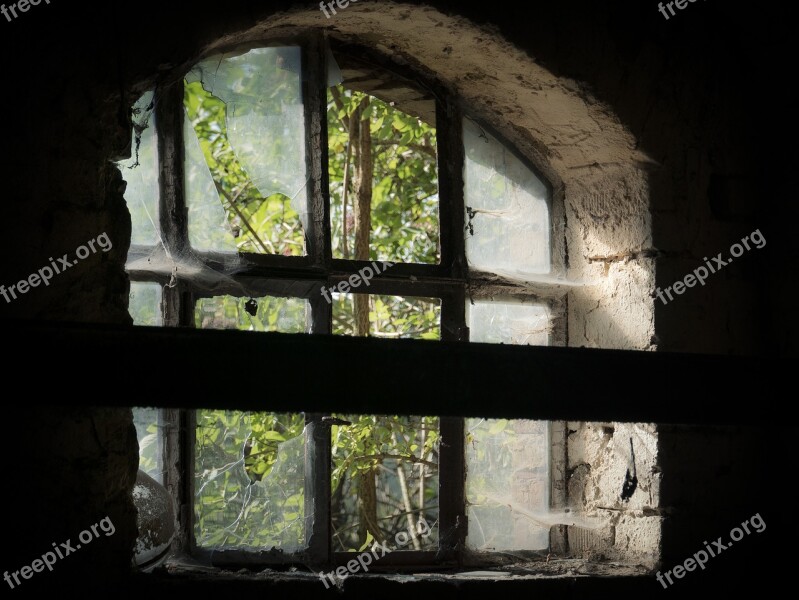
331, 415, 439, 552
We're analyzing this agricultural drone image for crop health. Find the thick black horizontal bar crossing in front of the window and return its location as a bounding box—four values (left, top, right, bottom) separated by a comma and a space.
3, 320, 780, 425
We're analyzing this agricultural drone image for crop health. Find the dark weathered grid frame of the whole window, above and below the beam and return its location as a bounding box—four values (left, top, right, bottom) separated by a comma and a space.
128, 32, 566, 572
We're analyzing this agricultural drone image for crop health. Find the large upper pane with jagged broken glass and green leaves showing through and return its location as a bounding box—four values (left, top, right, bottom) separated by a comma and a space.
184, 47, 308, 256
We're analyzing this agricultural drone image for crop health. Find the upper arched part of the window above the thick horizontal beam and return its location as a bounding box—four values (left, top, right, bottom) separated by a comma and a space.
123, 40, 562, 345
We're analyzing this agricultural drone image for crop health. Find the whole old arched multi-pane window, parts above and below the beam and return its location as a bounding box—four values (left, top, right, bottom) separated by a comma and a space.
120, 36, 564, 567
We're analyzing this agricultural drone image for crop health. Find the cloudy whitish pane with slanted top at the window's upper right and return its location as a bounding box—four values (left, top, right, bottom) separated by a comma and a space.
463, 119, 550, 280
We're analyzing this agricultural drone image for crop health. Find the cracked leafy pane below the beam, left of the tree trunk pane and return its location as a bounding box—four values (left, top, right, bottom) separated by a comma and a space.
194, 410, 306, 552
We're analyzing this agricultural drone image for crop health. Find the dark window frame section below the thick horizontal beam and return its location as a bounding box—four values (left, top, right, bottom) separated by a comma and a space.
159, 407, 568, 573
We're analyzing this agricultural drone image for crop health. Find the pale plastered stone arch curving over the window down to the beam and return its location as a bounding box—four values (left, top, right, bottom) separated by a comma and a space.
167, 3, 657, 350
